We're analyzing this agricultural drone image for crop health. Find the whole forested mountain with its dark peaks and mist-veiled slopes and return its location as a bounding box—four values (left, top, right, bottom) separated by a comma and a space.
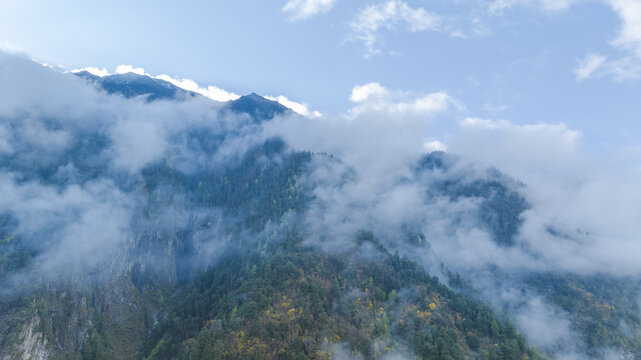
0, 55, 641, 360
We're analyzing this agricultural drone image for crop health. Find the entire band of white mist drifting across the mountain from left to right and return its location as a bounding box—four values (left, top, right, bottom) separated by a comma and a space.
0, 53, 641, 359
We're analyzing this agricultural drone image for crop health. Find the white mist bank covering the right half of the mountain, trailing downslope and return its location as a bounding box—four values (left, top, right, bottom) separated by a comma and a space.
255, 82, 641, 359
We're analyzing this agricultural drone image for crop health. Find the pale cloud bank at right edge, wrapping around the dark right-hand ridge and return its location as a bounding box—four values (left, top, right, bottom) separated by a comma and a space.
433, 118, 641, 275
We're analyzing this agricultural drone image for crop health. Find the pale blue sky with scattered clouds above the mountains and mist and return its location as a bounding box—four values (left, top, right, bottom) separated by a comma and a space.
0, 0, 641, 152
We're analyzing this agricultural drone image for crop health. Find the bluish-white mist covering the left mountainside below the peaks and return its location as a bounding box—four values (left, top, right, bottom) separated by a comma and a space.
0, 53, 261, 295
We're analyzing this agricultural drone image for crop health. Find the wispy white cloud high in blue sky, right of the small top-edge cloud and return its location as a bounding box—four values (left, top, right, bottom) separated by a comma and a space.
348, 0, 441, 57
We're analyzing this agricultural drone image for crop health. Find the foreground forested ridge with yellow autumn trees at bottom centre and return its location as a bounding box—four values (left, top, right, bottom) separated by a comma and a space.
145, 234, 536, 359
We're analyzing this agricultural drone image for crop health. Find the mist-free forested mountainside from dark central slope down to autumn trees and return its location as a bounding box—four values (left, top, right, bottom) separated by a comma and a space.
0, 144, 536, 359
